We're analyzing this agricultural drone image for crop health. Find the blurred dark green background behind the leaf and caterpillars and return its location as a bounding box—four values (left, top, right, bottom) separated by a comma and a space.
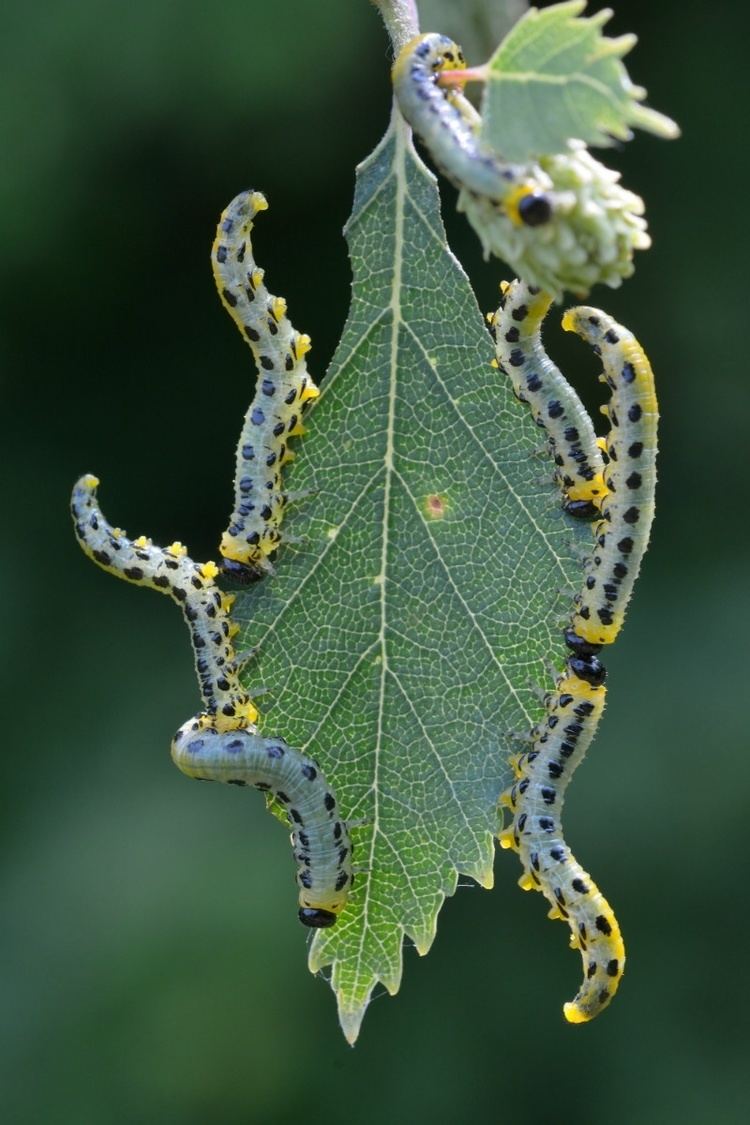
0, 0, 750, 1125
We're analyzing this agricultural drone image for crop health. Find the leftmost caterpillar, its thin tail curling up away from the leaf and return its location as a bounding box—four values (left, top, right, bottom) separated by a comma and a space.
71, 474, 257, 730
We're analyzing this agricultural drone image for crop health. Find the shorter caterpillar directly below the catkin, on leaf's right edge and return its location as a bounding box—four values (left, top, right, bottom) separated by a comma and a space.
488, 280, 606, 518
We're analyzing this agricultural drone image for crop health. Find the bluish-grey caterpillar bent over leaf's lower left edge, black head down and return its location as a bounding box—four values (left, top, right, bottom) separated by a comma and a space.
172, 720, 353, 929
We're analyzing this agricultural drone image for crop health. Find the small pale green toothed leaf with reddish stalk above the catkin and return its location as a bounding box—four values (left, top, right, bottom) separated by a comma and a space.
479, 0, 679, 163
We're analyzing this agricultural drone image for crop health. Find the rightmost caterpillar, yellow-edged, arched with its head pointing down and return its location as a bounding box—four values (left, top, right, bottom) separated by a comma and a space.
562, 306, 659, 651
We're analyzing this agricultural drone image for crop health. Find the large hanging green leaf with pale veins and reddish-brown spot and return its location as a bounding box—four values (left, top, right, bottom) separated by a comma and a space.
235, 118, 588, 1042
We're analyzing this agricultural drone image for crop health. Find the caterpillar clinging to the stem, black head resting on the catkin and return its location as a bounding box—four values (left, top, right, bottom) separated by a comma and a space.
391, 34, 552, 226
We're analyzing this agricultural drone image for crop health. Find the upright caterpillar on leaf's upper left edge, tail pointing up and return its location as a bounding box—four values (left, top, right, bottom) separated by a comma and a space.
211, 191, 319, 581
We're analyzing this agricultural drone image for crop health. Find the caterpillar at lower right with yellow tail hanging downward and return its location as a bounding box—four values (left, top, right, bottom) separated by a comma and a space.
499, 656, 625, 1024
